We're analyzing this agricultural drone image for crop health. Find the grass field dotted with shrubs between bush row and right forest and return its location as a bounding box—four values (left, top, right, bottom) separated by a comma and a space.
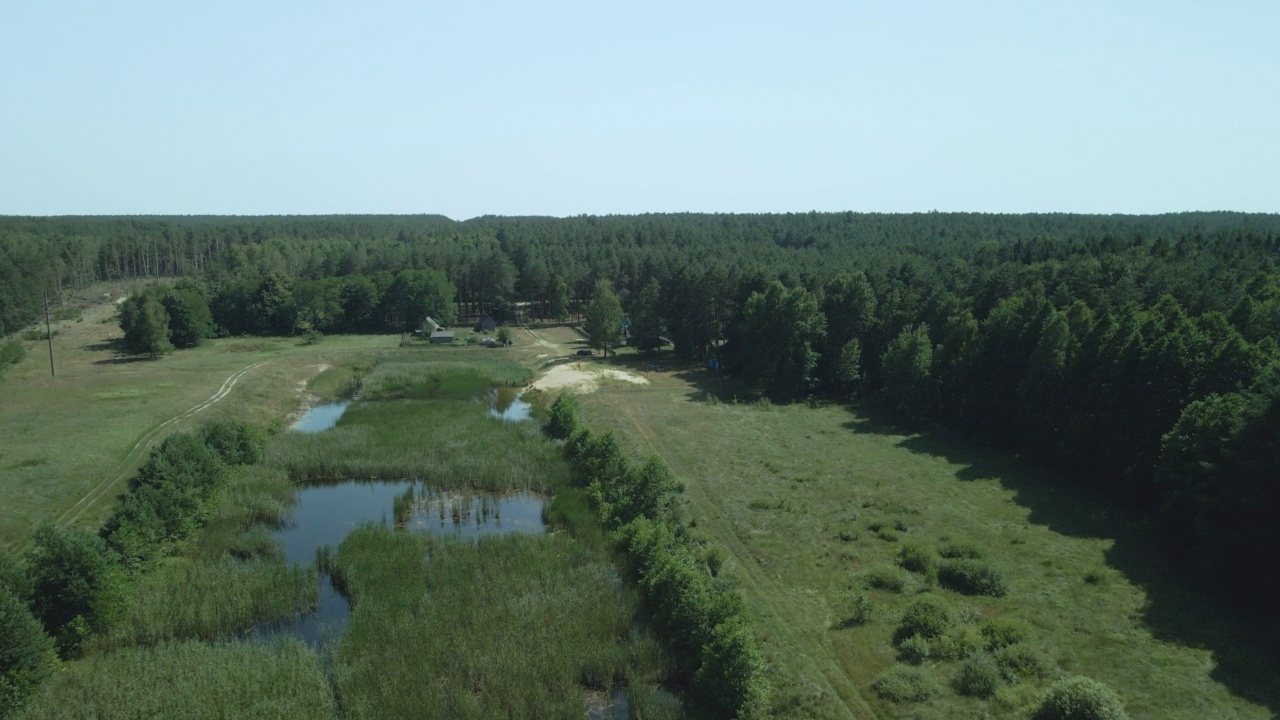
517, 328, 1280, 720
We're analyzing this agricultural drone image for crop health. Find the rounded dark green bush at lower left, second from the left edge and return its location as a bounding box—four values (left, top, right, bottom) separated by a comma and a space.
27, 525, 124, 653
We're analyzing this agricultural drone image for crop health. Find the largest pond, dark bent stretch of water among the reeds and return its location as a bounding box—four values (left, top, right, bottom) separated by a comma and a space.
253, 480, 547, 647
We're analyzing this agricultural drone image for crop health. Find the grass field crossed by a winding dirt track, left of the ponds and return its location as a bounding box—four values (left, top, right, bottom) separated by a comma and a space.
0, 293, 398, 552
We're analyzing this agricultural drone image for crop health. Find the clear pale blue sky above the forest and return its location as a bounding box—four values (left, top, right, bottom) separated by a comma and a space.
0, 0, 1280, 219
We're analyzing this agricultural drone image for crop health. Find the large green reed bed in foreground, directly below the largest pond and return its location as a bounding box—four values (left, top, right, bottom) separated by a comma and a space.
333, 525, 673, 719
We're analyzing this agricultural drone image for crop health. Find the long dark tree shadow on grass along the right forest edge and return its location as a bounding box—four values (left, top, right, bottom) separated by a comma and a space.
845, 407, 1280, 716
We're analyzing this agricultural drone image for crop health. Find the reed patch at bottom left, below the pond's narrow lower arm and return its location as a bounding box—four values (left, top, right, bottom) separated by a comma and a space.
18, 639, 337, 720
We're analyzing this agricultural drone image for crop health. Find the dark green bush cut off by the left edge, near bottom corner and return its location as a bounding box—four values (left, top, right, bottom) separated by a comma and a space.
0, 587, 58, 717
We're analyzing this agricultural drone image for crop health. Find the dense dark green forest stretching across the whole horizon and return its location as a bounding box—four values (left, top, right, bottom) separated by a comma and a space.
0, 213, 1280, 617
